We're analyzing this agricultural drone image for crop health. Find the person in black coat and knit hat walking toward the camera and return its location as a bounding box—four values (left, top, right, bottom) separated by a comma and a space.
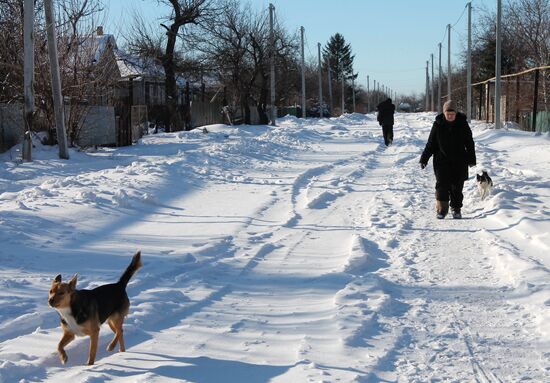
420, 100, 476, 219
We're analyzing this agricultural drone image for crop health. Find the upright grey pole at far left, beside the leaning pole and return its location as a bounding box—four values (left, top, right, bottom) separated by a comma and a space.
21, 0, 34, 161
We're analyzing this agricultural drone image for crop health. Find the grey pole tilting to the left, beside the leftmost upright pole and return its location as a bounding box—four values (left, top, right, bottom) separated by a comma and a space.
44, 0, 69, 160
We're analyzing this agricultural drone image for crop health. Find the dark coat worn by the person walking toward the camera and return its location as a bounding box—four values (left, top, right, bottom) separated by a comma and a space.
420, 113, 476, 183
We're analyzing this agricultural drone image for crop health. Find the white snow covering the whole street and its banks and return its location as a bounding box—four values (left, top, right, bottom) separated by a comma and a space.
0, 113, 550, 383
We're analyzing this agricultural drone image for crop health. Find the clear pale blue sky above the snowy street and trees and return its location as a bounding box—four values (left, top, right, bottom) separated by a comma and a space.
105, 0, 496, 95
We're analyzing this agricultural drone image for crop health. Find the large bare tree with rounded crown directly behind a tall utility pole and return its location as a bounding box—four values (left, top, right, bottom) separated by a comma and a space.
194, 0, 299, 123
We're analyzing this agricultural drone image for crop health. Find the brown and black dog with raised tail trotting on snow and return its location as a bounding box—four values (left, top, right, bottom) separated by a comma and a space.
48, 251, 142, 365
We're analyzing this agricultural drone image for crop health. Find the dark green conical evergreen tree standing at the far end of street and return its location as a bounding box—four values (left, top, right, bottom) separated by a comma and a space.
323, 33, 357, 80
